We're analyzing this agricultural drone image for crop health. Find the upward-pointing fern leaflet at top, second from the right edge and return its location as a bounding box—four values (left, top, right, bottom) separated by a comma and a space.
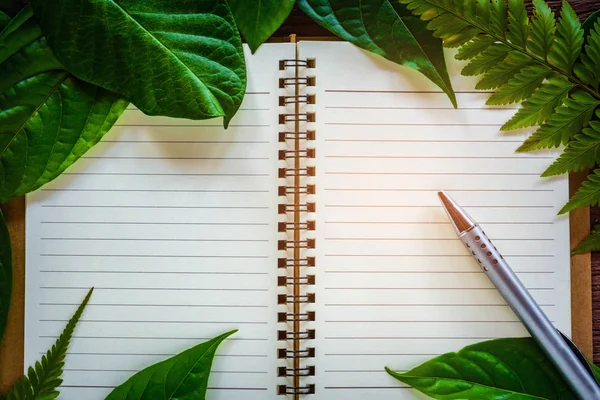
548, 1, 583, 73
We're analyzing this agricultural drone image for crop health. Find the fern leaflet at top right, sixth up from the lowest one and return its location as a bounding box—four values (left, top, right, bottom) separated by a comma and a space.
486, 64, 551, 105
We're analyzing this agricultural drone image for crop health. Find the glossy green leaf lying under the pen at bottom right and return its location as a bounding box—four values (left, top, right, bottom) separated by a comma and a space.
386, 338, 577, 400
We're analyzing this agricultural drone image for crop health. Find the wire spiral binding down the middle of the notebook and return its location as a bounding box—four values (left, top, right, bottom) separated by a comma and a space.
277, 59, 316, 399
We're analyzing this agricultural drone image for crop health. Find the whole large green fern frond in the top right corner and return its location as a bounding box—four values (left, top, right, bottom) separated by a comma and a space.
400, 0, 600, 238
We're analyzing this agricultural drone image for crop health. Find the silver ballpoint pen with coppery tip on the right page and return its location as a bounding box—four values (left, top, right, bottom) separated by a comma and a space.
438, 191, 600, 400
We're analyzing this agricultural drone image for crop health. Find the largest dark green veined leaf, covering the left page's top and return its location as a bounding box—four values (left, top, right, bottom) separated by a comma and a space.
33, 0, 246, 126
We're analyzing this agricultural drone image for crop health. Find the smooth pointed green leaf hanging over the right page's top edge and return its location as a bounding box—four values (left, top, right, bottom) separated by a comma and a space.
298, 0, 458, 107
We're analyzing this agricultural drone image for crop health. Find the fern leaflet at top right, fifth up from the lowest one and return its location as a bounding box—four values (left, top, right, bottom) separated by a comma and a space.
501, 78, 574, 131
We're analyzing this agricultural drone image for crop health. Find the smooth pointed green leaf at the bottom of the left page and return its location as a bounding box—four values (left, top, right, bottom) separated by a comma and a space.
105, 331, 237, 400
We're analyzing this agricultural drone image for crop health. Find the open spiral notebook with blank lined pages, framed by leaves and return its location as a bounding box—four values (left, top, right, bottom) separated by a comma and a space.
25, 42, 570, 400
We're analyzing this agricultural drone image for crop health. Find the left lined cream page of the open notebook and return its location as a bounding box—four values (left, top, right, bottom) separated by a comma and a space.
25, 44, 295, 400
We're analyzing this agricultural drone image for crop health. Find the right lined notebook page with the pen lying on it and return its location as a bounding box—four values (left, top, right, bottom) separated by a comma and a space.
300, 42, 570, 400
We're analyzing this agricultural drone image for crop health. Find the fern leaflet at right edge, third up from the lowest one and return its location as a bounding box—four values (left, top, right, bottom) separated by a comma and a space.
542, 116, 600, 176
